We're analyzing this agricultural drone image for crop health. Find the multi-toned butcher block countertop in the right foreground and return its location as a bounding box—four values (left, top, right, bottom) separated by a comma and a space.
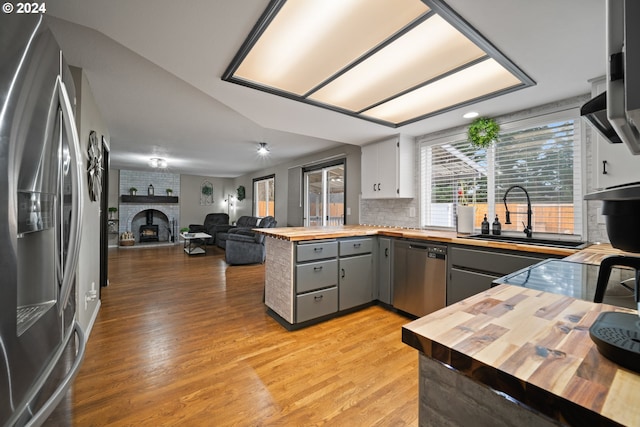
402, 285, 640, 426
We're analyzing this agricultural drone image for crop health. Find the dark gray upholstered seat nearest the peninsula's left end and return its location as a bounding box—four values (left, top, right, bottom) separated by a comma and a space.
225, 216, 277, 265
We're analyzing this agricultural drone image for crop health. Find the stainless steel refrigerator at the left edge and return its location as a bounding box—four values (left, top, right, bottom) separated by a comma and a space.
0, 13, 85, 426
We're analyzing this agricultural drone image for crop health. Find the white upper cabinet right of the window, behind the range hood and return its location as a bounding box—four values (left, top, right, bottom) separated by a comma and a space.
591, 78, 640, 189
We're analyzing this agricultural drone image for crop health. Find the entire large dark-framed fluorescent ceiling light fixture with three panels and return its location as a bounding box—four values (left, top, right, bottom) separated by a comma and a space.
222, 0, 535, 127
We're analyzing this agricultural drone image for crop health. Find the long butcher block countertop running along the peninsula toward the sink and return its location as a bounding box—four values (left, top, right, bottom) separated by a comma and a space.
256, 225, 578, 256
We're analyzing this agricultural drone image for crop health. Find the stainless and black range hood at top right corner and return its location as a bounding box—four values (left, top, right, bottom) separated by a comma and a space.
580, 0, 640, 155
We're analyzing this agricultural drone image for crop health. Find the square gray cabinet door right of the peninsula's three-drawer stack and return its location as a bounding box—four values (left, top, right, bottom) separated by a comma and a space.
338, 254, 373, 310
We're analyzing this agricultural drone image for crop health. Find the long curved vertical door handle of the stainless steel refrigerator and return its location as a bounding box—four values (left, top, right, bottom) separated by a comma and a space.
57, 75, 83, 313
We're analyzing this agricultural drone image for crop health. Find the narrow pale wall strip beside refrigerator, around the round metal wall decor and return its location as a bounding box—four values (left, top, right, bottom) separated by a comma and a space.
71, 67, 109, 334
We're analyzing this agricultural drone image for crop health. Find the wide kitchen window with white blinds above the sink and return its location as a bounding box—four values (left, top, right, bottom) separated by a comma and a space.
420, 110, 582, 236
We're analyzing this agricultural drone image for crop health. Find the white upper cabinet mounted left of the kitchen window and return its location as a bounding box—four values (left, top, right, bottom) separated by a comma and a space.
361, 135, 415, 199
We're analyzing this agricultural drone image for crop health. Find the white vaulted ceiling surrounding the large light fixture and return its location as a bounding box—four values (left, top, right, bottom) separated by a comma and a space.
47, 0, 606, 177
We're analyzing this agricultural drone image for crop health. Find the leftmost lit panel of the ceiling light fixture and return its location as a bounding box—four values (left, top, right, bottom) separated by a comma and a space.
234, 0, 429, 95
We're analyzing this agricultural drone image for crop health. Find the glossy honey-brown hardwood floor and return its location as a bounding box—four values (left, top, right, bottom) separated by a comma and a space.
67, 246, 418, 426
